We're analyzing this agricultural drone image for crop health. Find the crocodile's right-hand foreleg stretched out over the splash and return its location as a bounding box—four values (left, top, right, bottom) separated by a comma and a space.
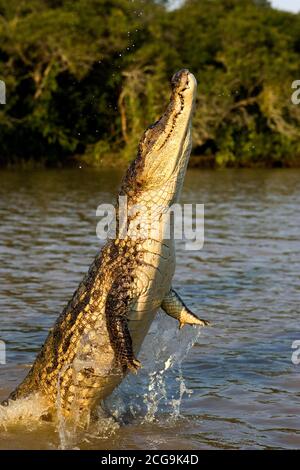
161, 289, 210, 329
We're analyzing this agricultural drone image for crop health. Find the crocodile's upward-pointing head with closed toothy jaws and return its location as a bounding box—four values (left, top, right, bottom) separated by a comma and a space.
122, 69, 197, 204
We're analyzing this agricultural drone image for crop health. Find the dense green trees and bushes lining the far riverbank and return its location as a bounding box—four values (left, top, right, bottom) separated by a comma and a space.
0, 0, 300, 167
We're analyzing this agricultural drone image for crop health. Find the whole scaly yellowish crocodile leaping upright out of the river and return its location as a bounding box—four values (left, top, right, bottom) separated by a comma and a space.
2, 69, 208, 422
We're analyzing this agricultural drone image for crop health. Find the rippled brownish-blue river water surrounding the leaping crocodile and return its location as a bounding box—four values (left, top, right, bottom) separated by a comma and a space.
0, 170, 300, 449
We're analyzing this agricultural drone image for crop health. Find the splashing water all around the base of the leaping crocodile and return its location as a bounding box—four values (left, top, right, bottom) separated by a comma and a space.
0, 313, 201, 449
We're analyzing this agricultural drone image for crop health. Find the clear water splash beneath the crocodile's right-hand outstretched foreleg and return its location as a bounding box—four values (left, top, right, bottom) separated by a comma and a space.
106, 313, 201, 423
